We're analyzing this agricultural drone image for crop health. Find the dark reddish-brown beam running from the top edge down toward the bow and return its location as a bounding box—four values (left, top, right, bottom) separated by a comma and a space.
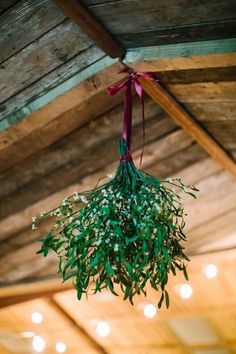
54, 0, 125, 58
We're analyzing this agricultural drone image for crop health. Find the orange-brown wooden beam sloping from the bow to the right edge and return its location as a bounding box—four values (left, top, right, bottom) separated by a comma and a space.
140, 79, 236, 177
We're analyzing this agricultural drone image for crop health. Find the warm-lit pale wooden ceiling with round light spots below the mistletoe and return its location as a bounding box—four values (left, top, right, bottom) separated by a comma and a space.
0, 252, 236, 354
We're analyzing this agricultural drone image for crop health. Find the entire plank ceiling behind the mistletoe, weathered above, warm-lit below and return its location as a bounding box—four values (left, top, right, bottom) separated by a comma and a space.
0, 0, 236, 354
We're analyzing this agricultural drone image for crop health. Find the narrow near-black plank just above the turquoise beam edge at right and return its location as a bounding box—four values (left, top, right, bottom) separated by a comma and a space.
117, 20, 236, 48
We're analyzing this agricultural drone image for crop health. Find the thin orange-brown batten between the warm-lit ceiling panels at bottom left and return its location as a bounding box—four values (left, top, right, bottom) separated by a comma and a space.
48, 297, 108, 354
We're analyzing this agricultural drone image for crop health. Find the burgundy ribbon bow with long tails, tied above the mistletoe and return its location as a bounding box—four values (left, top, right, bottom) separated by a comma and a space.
107, 67, 154, 165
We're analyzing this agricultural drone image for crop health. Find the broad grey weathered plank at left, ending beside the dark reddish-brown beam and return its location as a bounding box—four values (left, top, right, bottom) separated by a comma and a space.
0, 20, 92, 102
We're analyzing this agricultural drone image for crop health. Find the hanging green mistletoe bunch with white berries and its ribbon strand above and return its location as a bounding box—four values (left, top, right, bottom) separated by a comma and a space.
33, 68, 196, 307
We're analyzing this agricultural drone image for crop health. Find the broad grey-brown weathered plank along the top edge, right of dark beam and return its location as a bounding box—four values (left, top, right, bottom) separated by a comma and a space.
84, 0, 236, 34
